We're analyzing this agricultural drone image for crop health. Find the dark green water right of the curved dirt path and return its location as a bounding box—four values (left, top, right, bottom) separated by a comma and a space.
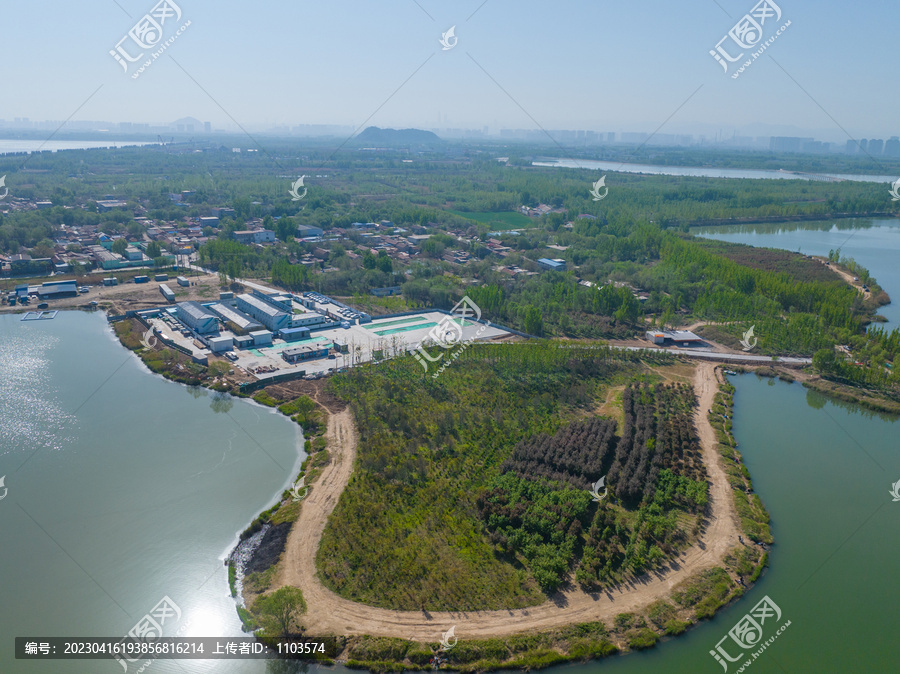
560, 375, 900, 674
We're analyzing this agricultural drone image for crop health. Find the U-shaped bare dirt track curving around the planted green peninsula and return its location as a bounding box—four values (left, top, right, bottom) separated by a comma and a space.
274, 363, 738, 641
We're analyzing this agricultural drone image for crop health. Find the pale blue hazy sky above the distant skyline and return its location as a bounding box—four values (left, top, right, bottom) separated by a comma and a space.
0, 0, 900, 142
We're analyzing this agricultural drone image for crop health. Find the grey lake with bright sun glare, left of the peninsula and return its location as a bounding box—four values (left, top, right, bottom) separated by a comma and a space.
0, 311, 303, 674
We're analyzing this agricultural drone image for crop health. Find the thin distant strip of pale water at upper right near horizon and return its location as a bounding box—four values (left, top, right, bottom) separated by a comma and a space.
532, 159, 897, 183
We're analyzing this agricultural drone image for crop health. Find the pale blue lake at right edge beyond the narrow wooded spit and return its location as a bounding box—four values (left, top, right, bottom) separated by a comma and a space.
691, 218, 900, 330
